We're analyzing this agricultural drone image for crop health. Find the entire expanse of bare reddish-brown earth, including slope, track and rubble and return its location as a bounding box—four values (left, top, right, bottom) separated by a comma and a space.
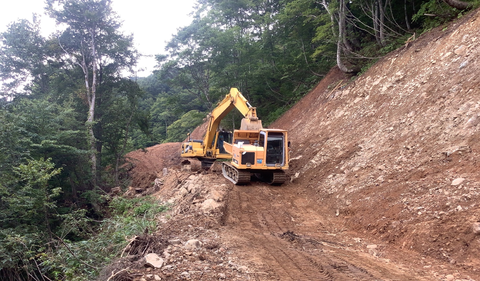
121, 8, 480, 280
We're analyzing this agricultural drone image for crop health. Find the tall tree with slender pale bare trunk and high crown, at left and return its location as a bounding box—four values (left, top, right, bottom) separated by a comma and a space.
47, 0, 136, 186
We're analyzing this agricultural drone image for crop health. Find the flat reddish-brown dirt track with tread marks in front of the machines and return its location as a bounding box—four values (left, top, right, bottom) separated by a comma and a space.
223, 183, 428, 281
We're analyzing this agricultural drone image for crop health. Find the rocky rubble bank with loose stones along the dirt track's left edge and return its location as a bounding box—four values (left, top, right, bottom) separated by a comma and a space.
102, 168, 250, 281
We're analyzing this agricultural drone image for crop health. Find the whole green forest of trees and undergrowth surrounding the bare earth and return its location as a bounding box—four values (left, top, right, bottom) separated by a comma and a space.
0, 0, 478, 280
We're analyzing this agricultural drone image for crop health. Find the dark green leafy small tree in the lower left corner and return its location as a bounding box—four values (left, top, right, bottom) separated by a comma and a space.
0, 159, 61, 280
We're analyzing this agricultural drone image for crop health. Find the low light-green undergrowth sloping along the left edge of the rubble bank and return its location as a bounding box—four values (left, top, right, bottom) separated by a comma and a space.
41, 197, 167, 281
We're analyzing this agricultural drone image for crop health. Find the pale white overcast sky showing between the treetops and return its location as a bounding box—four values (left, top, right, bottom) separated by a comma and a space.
0, 0, 195, 76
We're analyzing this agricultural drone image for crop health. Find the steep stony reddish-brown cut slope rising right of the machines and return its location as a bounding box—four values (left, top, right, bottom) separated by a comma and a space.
271, 11, 480, 272
